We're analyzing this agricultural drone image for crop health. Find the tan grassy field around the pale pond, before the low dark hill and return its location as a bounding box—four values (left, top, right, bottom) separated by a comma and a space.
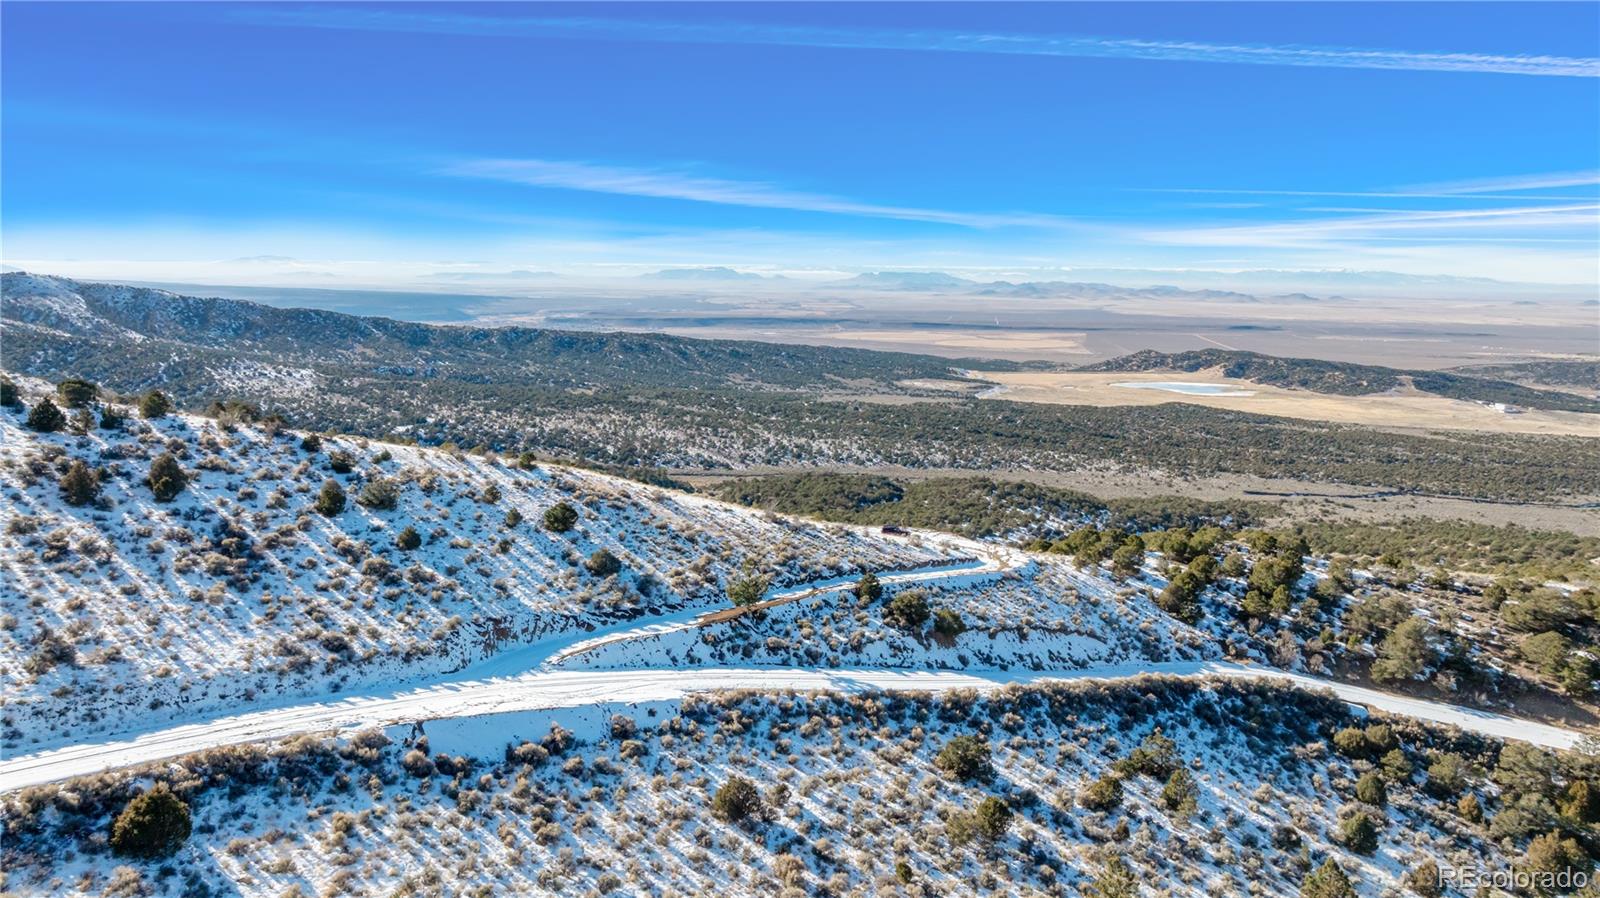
984, 371, 1600, 437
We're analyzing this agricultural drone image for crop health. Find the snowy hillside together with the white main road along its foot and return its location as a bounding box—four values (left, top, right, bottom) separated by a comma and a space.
0, 393, 1579, 789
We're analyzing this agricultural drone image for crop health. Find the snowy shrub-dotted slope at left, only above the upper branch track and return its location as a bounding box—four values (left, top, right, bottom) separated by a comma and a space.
0, 385, 949, 748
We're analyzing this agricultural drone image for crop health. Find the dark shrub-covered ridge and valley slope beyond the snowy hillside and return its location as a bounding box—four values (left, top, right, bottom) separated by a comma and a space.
0, 274, 1600, 499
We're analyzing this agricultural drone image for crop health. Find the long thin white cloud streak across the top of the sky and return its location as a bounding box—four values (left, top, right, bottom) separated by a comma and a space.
234, 6, 1600, 78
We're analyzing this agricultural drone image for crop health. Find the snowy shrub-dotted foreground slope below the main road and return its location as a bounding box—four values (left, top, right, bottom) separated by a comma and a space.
5, 677, 1560, 898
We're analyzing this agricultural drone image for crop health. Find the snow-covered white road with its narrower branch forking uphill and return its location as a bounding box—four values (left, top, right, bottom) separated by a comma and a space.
0, 535, 1584, 792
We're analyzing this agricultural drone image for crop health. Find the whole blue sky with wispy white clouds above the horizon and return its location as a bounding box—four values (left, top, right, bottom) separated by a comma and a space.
0, 2, 1600, 283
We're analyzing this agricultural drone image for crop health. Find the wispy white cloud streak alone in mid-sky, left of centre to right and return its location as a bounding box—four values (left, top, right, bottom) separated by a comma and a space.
442, 158, 1069, 229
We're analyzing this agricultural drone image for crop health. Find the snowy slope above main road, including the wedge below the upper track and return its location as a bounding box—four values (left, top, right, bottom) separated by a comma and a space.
0, 383, 1216, 749
